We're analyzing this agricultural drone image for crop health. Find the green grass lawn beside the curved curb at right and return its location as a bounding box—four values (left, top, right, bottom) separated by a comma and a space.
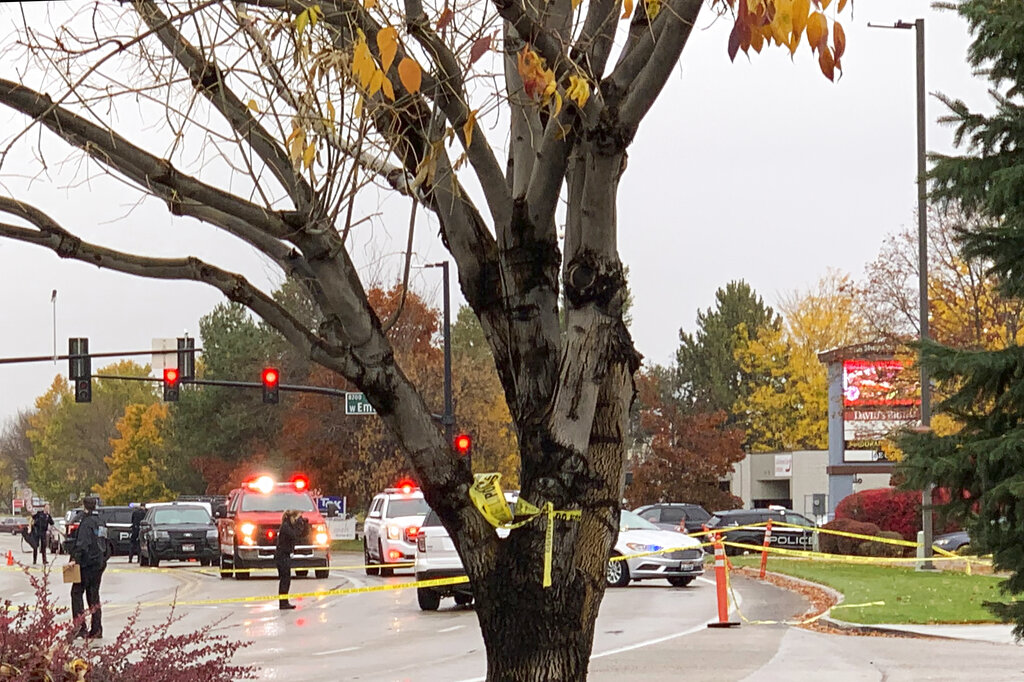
731, 555, 1006, 625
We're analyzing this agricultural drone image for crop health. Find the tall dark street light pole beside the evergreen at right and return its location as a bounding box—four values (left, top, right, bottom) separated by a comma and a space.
868, 18, 935, 570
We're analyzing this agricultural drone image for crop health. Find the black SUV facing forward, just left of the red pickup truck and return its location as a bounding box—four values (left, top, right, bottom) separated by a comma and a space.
138, 502, 220, 567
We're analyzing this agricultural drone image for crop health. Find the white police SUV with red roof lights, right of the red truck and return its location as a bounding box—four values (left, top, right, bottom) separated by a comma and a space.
362, 480, 430, 576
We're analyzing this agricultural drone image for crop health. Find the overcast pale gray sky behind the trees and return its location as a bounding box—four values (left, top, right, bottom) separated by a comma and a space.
0, 0, 988, 422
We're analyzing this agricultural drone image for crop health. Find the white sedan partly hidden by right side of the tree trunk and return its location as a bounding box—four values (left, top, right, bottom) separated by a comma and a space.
607, 509, 703, 587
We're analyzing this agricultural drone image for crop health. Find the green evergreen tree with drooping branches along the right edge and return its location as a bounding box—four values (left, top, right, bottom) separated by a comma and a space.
902, 0, 1024, 636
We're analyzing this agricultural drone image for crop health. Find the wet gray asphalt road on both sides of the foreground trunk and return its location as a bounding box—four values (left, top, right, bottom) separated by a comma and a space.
0, 536, 715, 682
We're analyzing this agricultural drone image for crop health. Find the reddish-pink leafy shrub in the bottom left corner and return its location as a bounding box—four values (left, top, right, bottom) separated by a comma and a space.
0, 571, 256, 682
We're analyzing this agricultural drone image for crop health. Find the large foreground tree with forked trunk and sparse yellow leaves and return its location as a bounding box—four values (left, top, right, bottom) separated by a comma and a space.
0, 0, 846, 680
